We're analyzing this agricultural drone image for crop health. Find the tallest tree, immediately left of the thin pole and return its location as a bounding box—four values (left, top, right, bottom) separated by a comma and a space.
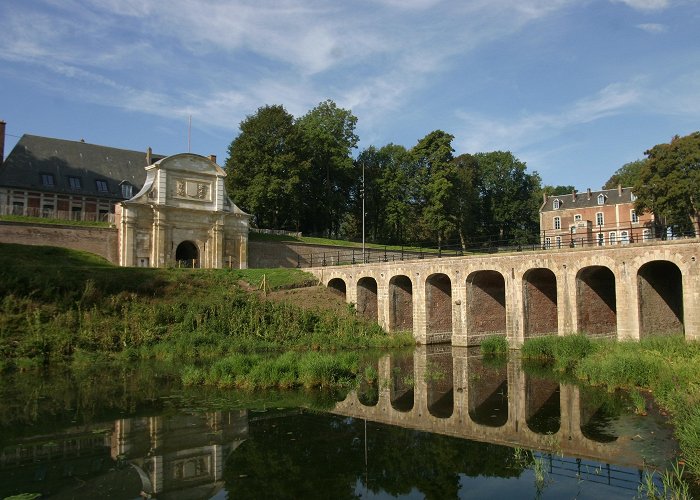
297, 99, 358, 236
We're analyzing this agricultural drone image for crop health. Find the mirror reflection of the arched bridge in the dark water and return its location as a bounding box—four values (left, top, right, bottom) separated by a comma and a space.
332, 347, 671, 467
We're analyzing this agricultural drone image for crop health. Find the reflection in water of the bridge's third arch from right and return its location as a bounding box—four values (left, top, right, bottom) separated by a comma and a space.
525, 377, 561, 434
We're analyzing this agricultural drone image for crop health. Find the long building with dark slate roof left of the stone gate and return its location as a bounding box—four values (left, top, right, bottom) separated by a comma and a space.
0, 127, 163, 221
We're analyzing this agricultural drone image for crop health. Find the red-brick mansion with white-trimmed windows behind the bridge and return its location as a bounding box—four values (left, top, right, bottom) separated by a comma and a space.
540, 186, 654, 248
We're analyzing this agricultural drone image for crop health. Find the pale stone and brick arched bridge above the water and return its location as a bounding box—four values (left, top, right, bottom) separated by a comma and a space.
310, 240, 700, 346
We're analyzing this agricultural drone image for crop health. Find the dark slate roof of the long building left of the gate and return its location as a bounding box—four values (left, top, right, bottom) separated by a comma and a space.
0, 134, 164, 201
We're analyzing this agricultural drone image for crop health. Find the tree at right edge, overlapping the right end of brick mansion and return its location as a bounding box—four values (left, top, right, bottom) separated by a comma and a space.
634, 132, 700, 234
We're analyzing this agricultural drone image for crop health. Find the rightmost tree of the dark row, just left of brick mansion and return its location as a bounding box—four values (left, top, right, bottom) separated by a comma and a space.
476, 151, 541, 243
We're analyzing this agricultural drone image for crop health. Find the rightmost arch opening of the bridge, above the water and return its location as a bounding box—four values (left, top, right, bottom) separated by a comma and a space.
637, 260, 684, 338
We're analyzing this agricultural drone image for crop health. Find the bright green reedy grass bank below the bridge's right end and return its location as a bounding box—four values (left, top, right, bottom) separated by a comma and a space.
521, 335, 700, 490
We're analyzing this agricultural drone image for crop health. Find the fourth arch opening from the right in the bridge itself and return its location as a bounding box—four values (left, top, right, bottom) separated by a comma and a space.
467, 271, 506, 337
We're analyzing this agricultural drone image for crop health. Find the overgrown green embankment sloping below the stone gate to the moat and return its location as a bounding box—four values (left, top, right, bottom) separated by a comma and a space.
0, 244, 413, 388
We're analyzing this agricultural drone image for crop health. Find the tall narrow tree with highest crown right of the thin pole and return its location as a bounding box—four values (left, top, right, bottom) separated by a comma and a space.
411, 130, 456, 248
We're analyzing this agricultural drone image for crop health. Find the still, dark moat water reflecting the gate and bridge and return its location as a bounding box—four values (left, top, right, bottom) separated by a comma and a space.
0, 347, 677, 499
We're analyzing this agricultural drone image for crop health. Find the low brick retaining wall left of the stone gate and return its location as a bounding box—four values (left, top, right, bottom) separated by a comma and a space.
0, 221, 119, 264
